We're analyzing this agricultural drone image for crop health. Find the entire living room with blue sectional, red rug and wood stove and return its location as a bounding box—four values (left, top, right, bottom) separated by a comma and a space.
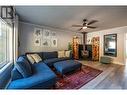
0, 6, 127, 89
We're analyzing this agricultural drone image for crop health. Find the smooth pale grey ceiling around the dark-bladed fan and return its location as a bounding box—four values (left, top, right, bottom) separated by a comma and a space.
15, 6, 127, 32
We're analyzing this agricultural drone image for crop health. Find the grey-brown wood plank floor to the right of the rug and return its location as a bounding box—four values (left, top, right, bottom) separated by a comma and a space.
80, 61, 127, 89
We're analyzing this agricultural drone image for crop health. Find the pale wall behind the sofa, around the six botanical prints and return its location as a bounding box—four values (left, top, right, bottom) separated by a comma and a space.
19, 22, 82, 54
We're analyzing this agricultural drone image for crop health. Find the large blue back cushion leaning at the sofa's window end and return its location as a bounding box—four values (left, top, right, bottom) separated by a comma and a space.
15, 56, 32, 78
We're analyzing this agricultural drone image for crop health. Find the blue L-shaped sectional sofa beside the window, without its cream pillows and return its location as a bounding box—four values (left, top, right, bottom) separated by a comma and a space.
8, 51, 72, 89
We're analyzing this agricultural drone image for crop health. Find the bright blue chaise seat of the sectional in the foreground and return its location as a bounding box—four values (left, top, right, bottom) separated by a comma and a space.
8, 62, 56, 89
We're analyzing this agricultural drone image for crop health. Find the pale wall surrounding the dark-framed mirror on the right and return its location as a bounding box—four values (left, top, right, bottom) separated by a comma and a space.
86, 26, 127, 65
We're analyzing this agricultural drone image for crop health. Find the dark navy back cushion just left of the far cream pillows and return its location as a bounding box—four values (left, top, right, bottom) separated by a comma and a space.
42, 51, 58, 60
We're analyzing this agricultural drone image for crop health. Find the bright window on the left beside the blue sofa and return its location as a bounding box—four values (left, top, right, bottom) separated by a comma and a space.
0, 18, 12, 68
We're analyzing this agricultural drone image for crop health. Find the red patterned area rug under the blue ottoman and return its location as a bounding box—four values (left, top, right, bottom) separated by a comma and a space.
56, 65, 102, 89
